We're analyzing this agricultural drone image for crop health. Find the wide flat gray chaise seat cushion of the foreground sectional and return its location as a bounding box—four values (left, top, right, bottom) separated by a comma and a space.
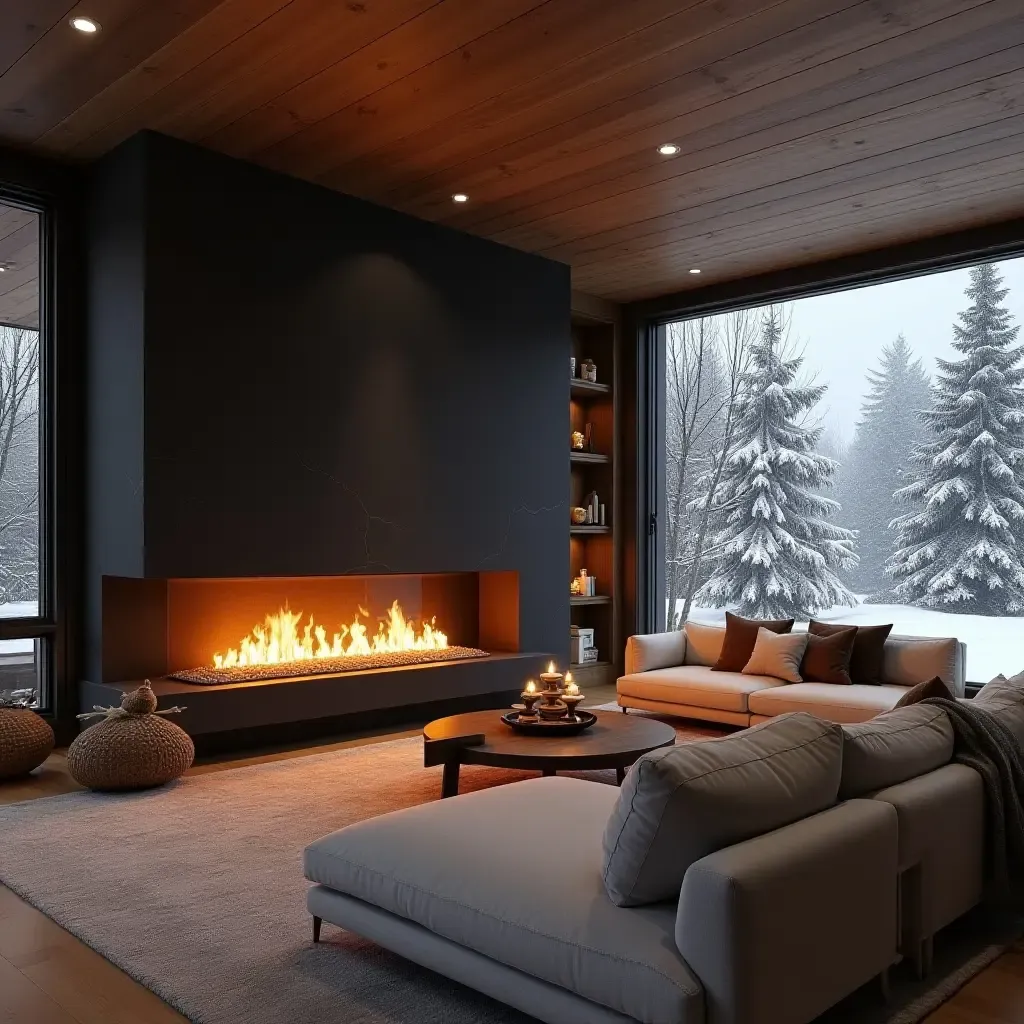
304, 778, 703, 1024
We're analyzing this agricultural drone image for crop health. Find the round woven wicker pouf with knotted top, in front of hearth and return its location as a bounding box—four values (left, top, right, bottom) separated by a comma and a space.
68, 681, 196, 791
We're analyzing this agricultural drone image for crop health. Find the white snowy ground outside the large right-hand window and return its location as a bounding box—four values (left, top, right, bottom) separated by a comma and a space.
679, 601, 1024, 683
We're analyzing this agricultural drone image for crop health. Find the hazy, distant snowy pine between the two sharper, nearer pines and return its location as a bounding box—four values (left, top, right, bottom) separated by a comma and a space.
836, 334, 931, 594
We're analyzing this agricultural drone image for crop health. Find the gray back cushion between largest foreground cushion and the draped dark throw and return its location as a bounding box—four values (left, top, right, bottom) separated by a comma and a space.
839, 705, 953, 800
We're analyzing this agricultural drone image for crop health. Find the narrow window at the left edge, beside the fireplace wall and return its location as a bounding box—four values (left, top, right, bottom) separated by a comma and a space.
0, 201, 45, 708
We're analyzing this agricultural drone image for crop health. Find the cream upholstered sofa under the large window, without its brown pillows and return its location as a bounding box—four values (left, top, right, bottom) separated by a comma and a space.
616, 623, 966, 725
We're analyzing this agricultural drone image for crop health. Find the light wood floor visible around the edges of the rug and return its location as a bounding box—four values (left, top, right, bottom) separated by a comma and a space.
0, 690, 1024, 1024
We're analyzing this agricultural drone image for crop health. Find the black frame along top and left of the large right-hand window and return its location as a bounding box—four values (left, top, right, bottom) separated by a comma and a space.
628, 218, 1024, 671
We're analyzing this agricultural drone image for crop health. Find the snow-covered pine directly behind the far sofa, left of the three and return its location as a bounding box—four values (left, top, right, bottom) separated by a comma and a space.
695, 307, 857, 618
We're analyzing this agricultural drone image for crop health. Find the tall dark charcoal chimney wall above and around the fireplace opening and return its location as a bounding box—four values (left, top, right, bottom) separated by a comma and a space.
86, 133, 569, 678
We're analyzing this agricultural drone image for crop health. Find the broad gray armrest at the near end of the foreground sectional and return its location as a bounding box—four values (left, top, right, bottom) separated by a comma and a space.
676, 800, 898, 1024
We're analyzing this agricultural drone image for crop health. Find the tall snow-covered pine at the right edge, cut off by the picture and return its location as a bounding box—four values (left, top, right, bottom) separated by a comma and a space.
886, 263, 1024, 615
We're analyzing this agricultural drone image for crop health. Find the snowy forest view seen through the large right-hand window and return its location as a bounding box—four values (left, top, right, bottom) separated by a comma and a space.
663, 260, 1024, 680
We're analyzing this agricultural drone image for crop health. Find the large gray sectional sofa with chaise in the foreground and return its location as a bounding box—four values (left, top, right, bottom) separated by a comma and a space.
304, 681, 1024, 1024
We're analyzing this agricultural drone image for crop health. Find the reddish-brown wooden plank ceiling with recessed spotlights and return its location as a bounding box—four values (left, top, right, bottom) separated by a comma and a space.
0, 0, 1024, 300
